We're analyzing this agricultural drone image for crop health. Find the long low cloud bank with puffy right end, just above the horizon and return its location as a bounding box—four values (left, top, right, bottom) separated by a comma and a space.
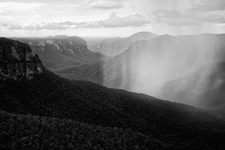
3, 12, 151, 30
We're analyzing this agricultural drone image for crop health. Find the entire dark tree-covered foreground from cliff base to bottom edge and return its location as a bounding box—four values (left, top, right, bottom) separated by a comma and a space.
0, 70, 225, 149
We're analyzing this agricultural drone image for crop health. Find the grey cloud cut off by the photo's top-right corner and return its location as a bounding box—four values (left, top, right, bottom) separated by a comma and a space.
191, 0, 225, 11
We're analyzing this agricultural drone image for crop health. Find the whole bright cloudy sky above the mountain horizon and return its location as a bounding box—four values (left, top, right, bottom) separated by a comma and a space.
0, 0, 225, 37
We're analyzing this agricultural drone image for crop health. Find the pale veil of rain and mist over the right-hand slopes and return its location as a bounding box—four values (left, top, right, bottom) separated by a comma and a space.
103, 34, 225, 107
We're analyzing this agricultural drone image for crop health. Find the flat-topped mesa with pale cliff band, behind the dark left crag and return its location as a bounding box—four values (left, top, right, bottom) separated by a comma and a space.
15, 35, 106, 70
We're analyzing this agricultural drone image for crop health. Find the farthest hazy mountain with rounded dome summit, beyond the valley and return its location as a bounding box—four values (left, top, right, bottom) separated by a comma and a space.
90, 32, 157, 57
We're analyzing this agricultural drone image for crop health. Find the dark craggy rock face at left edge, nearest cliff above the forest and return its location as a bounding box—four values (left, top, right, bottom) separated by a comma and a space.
0, 38, 43, 80
